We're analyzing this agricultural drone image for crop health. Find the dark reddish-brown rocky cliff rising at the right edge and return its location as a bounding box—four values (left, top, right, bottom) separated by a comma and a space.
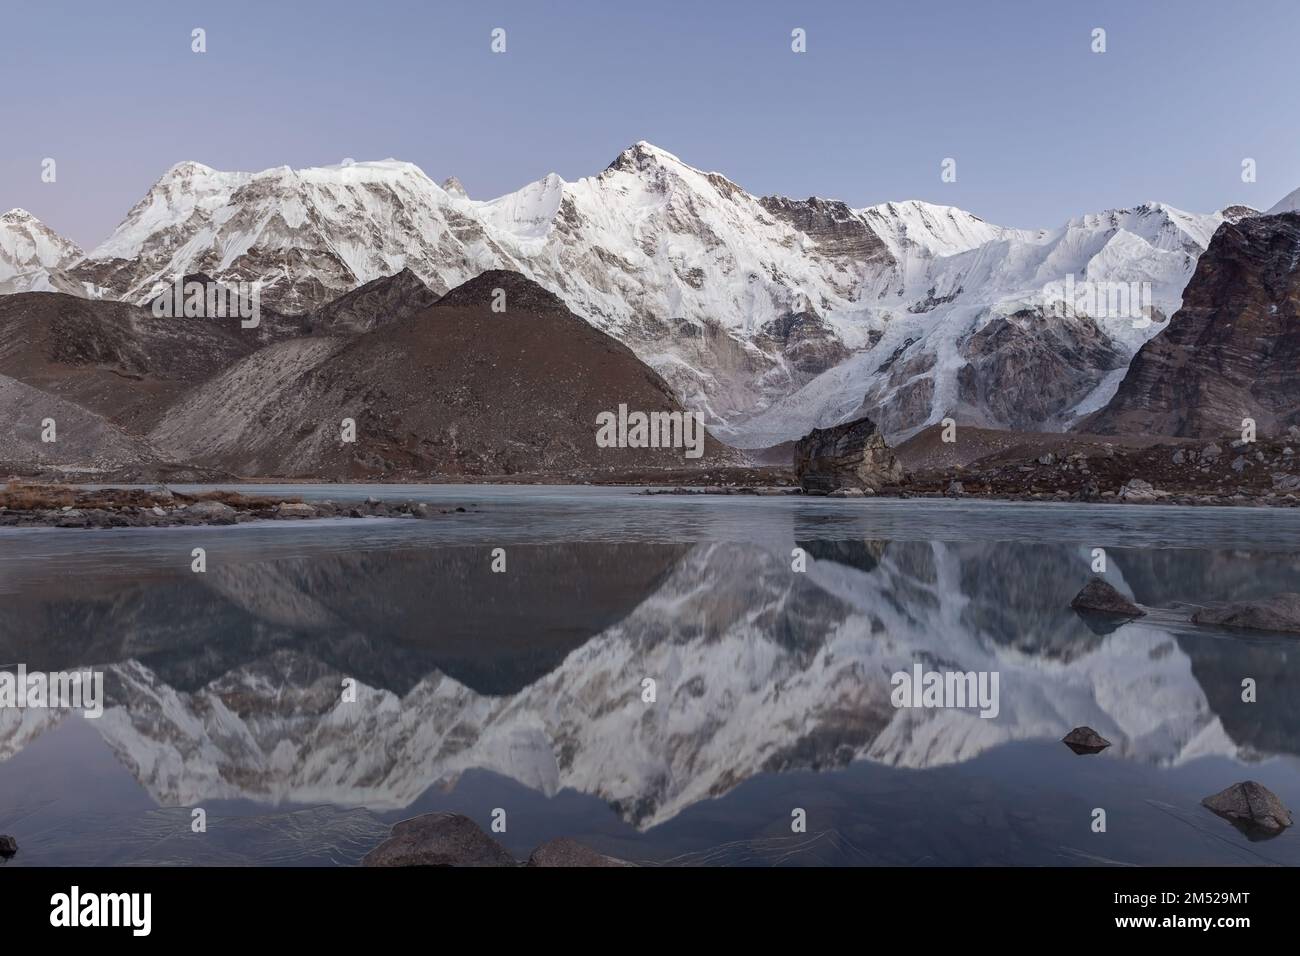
1075, 213, 1300, 437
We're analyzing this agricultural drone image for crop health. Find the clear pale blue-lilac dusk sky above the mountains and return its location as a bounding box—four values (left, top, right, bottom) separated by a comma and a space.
0, 0, 1300, 248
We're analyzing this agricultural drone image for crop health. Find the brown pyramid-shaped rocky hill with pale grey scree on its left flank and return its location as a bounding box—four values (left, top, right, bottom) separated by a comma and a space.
151, 272, 738, 481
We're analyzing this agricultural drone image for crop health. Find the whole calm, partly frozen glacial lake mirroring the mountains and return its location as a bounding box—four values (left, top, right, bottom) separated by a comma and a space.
0, 485, 1300, 866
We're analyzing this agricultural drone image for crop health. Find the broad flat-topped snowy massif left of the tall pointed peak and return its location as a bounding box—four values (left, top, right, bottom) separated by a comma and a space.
65, 160, 503, 312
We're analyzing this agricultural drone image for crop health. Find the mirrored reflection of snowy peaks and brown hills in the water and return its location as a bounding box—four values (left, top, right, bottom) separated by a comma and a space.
0, 519, 1300, 830
